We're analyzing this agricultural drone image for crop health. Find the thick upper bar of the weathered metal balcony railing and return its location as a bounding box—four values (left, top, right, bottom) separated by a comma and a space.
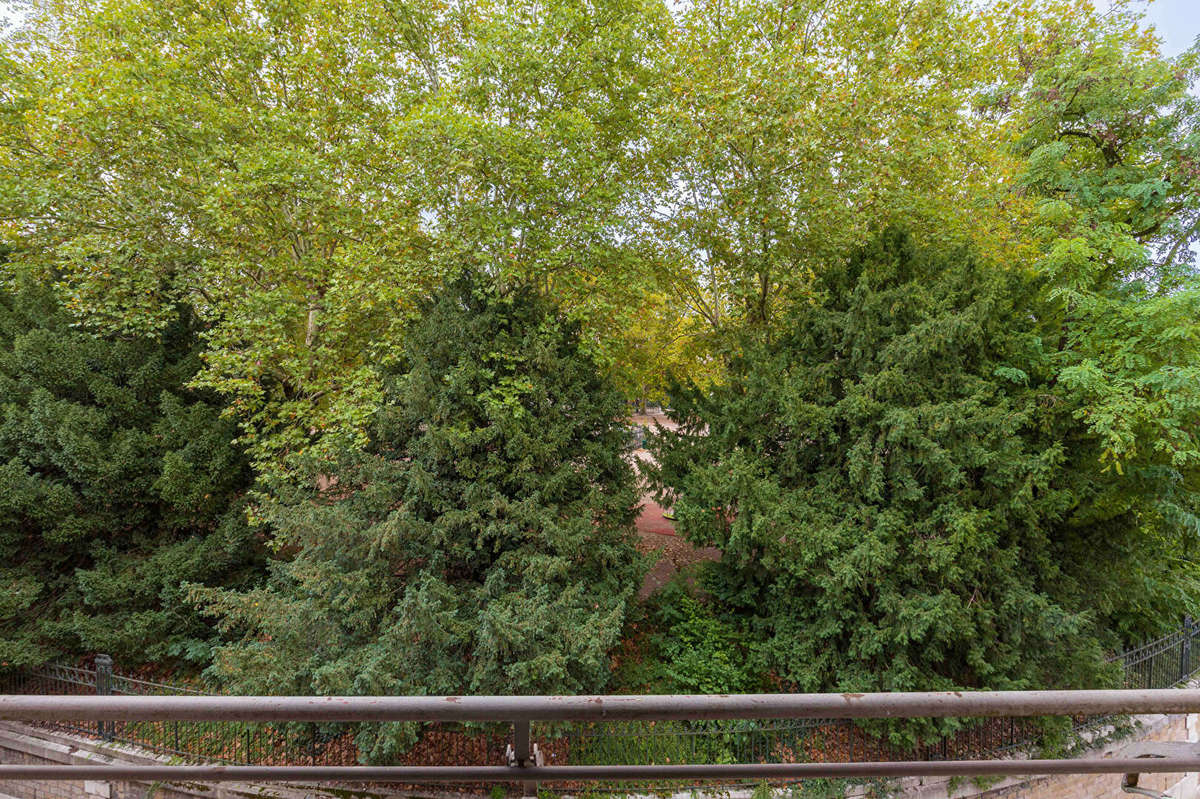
7, 689, 1200, 721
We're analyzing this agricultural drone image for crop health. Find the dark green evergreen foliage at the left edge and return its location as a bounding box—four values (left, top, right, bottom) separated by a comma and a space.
0, 273, 259, 665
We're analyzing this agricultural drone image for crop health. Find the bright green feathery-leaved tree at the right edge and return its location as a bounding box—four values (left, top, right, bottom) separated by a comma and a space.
984, 2, 1200, 499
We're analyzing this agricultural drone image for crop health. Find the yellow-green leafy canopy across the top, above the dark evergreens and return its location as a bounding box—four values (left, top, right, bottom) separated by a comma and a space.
0, 0, 1200, 460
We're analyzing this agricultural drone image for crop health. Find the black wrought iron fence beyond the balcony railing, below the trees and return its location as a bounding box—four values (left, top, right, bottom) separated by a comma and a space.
0, 619, 1200, 765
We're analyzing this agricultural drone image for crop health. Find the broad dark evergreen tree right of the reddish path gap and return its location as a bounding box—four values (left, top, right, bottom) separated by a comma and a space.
650, 233, 1200, 710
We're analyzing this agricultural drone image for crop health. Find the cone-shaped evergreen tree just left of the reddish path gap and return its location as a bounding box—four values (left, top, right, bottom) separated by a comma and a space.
197, 274, 641, 758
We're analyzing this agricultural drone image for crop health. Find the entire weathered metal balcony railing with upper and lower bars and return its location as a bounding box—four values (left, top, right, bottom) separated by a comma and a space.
0, 689, 1200, 785
